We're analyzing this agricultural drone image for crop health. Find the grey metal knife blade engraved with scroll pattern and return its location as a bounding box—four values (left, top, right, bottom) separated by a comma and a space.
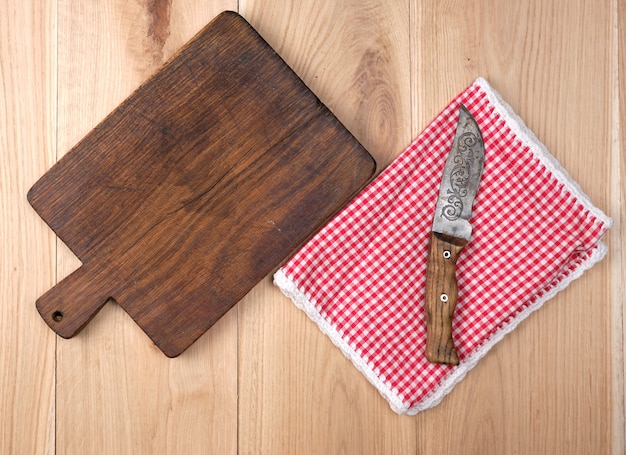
433, 105, 485, 240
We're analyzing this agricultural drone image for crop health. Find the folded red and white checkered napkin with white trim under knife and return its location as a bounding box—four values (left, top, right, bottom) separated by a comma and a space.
274, 79, 611, 414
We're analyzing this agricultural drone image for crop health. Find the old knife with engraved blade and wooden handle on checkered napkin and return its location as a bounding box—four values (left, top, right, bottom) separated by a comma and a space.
426, 104, 485, 365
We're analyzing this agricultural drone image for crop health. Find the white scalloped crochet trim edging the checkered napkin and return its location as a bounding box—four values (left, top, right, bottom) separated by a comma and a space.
274, 78, 612, 415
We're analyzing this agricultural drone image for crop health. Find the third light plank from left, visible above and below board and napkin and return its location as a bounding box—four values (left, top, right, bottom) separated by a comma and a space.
234, 0, 416, 454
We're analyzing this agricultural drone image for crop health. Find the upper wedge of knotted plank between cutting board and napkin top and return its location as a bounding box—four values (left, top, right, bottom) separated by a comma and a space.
240, 0, 412, 169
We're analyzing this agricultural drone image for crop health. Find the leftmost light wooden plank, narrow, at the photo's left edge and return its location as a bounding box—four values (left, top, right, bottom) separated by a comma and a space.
0, 0, 56, 454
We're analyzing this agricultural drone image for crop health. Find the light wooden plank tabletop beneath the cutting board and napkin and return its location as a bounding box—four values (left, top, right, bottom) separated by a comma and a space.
0, 0, 626, 454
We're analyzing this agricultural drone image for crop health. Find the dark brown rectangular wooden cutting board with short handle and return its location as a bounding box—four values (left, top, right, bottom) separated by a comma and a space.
28, 12, 375, 357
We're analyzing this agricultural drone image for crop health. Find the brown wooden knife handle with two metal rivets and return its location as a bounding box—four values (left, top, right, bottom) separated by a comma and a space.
426, 232, 467, 365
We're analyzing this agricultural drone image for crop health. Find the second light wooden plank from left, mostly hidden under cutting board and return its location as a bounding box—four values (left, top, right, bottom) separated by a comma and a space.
56, 0, 237, 454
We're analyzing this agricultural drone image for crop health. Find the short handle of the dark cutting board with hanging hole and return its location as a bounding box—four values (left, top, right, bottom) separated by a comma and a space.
36, 265, 111, 338
